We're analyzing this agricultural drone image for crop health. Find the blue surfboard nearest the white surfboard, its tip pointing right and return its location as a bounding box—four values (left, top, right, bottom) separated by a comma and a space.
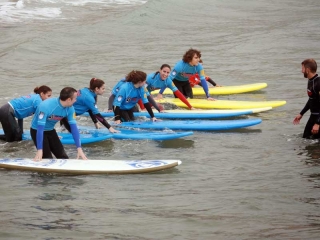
78, 126, 193, 141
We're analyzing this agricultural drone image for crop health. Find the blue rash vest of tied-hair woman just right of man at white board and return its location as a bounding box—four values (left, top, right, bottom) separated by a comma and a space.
73, 88, 100, 115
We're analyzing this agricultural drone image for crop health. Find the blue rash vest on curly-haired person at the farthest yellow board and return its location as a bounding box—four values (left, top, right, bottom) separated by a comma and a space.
165, 60, 210, 98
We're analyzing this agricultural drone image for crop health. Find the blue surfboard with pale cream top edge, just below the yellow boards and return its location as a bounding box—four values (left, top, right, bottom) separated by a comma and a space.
82, 107, 272, 119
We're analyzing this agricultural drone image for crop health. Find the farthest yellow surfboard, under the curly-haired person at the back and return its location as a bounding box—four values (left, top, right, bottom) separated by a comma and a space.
151, 83, 267, 96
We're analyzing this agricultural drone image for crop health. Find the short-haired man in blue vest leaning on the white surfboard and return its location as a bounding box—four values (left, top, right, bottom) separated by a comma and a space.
30, 87, 87, 161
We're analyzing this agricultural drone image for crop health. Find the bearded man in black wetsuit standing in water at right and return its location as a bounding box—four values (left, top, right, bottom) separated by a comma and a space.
293, 59, 320, 139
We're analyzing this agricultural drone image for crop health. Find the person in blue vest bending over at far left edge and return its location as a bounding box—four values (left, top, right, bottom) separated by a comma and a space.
0, 85, 52, 142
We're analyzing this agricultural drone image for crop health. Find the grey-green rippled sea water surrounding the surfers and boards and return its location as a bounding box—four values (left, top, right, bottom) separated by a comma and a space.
0, 0, 320, 240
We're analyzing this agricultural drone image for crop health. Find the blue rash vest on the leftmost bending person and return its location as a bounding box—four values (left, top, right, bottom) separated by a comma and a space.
8, 93, 42, 119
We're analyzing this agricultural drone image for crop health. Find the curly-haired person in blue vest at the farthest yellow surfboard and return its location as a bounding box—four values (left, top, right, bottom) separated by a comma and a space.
159, 48, 215, 101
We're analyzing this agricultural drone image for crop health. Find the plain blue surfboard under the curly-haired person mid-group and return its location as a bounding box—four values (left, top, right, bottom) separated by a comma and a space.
110, 118, 262, 131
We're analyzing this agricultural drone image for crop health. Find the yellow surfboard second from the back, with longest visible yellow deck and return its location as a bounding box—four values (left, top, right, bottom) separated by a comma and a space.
156, 98, 286, 109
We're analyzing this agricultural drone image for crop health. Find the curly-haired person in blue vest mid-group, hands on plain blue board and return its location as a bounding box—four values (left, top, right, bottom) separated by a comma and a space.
113, 71, 157, 124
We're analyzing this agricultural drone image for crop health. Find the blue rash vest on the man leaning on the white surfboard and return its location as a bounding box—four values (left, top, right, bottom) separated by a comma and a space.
31, 98, 77, 131
